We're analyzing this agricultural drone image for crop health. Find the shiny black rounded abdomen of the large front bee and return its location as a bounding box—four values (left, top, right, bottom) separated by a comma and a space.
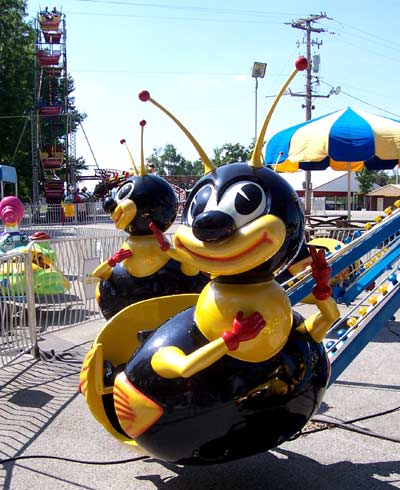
125, 308, 329, 464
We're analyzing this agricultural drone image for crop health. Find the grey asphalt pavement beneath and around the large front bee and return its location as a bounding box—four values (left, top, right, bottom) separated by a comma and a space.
0, 302, 400, 490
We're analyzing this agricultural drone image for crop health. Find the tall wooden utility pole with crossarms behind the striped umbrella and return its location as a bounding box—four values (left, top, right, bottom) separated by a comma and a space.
289, 12, 329, 216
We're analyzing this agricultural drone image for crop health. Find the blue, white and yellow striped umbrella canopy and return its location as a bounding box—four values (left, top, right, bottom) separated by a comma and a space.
265, 107, 400, 219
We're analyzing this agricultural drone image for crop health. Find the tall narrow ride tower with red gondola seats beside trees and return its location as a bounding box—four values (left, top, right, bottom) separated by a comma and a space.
31, 7, 75, 204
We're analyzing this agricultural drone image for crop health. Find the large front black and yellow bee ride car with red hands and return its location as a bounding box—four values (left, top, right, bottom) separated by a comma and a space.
80, 58, 339, 464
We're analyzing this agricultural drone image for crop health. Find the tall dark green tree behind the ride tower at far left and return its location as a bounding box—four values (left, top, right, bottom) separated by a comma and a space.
0, 0, 86, 200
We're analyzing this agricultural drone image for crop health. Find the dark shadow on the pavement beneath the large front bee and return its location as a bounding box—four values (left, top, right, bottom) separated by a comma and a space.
136, 450, 400, 490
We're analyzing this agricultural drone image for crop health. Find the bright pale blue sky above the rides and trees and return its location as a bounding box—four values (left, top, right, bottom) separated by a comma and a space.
28, 0, 400, 189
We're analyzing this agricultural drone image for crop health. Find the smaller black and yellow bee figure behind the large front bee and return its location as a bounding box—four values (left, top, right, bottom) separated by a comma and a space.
92, 121, 208, 319
